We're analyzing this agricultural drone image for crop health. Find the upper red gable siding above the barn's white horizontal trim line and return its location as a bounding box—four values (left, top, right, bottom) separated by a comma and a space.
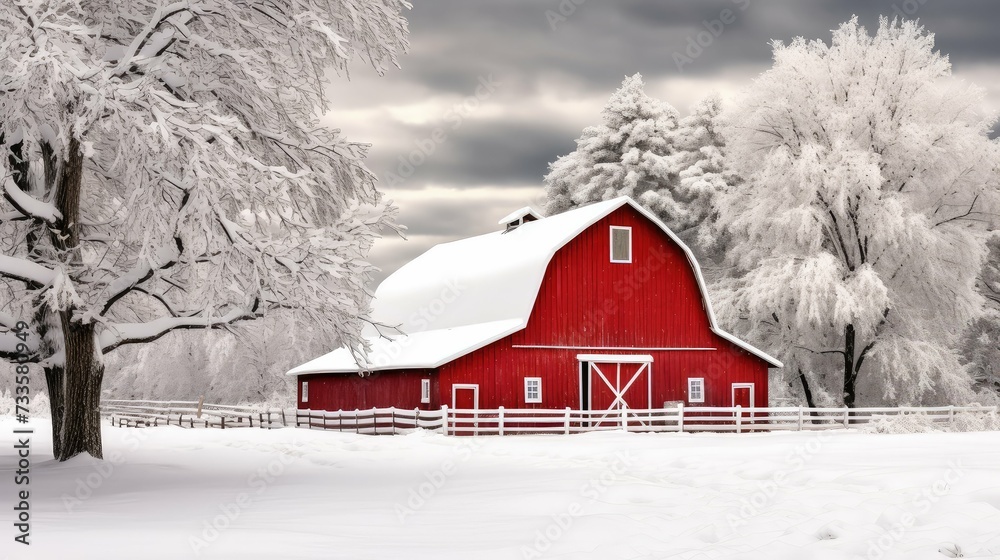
513, 206, 717, 348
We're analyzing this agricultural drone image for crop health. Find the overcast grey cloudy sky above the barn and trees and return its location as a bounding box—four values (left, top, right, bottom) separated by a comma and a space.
329, 0, 1000, 281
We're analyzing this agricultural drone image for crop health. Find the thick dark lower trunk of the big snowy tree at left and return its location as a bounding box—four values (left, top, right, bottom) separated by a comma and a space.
57, 316, 104, 461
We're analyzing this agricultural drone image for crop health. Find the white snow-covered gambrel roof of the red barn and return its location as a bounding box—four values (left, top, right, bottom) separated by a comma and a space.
288, 197, 781, 375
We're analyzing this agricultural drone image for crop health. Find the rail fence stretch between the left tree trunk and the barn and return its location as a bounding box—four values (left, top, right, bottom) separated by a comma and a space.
101, 400, 287, 429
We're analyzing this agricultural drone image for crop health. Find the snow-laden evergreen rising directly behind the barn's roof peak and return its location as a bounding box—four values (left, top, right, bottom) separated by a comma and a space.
545, 74, 688, 229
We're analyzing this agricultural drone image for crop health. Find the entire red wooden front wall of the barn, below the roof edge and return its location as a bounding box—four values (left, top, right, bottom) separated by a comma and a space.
439, 206, 767, 408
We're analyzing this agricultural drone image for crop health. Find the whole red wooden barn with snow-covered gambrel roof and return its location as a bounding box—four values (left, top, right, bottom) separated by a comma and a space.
289, 197, 781, 411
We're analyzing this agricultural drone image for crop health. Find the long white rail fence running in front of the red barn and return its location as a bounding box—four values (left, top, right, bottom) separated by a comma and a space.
295, 406, 1000, 436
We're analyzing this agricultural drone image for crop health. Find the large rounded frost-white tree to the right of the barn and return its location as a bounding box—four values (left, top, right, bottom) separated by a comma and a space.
716, 18, 997, 406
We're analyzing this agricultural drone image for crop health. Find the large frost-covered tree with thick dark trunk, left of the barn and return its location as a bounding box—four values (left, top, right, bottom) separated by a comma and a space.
0, 0, 409, 460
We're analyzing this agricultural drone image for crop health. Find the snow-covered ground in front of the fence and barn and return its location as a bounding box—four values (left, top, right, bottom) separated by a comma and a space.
0, 419, 1000, 560
